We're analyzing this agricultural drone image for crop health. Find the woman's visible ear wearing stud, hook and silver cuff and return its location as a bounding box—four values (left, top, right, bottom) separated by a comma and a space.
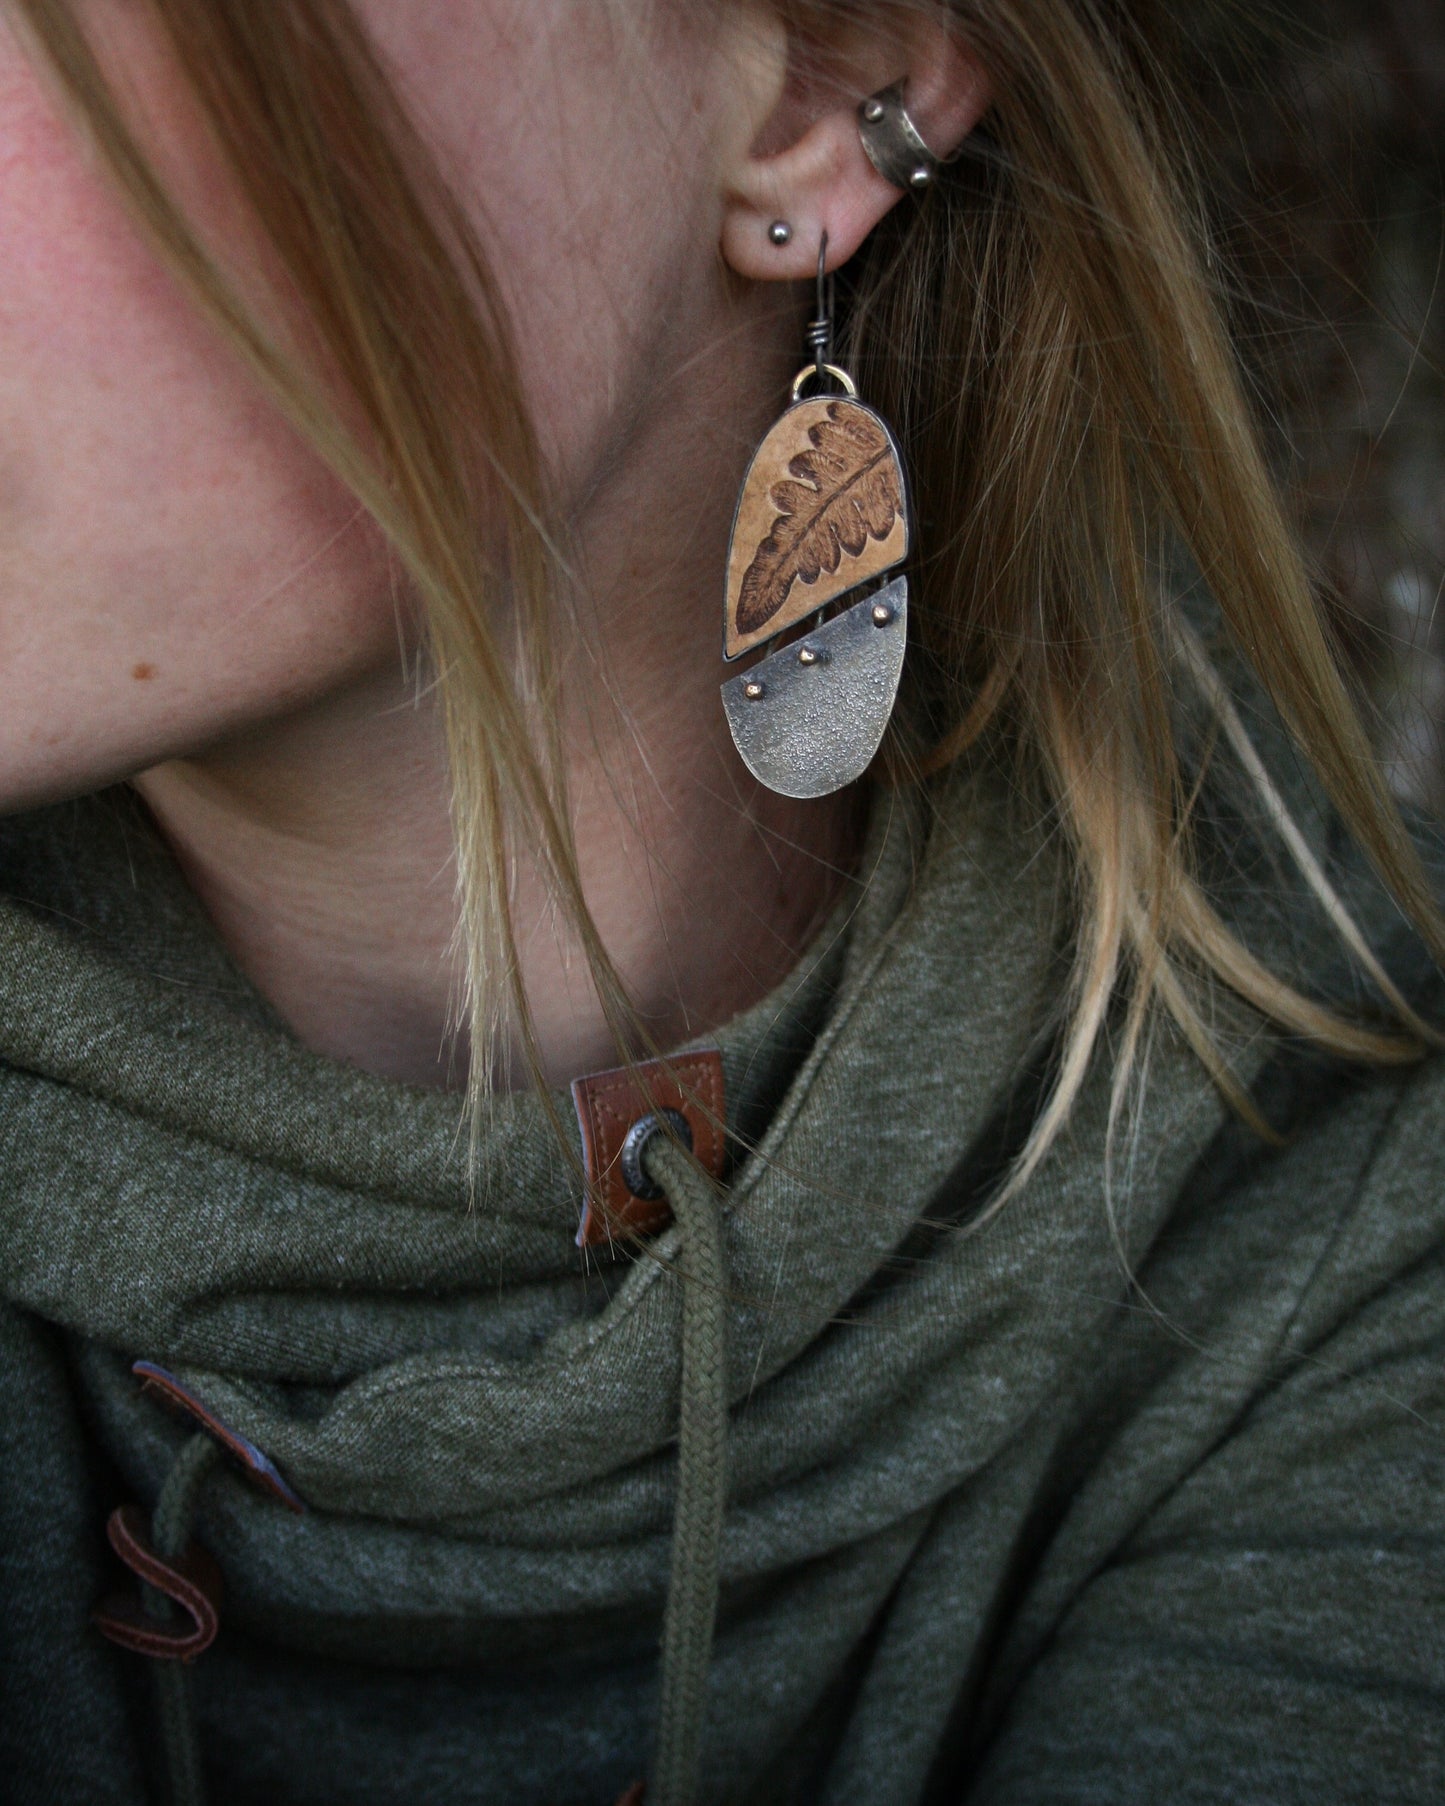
723, 14, 990, 282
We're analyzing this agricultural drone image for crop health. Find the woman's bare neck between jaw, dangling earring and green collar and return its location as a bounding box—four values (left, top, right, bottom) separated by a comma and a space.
135, 297, 856, 1085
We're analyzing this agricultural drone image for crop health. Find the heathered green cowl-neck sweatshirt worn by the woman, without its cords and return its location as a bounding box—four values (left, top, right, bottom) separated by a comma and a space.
0, 777, 1445, 1806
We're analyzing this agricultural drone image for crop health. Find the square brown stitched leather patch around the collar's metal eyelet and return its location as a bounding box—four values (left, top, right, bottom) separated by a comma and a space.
573, 1047, 726, 1248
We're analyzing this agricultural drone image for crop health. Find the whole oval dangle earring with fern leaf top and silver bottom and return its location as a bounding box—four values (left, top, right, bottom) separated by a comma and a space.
723, 233, 909, 796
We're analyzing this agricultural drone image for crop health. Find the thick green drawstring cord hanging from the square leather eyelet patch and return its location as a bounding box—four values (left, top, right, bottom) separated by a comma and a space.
641, 1134, 728, 1806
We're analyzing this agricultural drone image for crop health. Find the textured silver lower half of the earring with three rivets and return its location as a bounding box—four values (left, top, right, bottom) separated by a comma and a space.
723, 576, 909, 796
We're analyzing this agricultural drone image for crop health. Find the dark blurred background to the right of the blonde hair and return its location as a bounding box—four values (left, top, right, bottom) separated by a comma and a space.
1161, 0, 1445, 809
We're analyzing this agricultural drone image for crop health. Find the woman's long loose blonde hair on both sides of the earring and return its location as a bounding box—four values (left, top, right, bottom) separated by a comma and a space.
18, 0, 1445, 1185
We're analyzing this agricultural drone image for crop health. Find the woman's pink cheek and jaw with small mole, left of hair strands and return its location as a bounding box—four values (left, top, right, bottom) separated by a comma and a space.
0, 25, 396, 807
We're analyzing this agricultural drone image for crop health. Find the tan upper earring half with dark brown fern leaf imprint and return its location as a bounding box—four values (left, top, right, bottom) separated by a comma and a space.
723, 396, 909, 659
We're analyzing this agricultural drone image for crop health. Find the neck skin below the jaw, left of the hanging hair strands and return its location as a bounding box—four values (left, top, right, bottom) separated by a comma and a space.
135, 672, 464, 1085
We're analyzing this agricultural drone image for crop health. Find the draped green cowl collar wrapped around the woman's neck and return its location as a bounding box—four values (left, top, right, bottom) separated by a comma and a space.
0, 762, 1242, 1647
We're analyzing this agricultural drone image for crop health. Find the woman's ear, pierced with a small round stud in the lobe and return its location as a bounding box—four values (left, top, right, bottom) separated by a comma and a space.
721, 25, 990, 282
